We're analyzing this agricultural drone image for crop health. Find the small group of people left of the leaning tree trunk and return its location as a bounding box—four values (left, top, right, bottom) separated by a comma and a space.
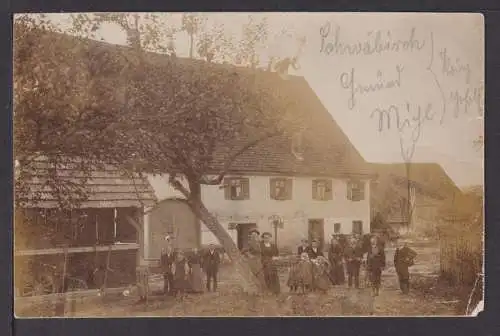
160, 236, 221, 296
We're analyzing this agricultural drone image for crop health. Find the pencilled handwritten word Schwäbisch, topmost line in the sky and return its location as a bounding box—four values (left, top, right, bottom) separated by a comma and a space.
320, 22, 425, 56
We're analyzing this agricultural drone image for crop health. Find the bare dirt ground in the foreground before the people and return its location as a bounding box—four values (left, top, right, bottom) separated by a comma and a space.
18, 240, 459, 317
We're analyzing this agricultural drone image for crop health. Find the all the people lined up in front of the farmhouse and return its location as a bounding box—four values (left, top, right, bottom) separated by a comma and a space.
160, 229, 416, 296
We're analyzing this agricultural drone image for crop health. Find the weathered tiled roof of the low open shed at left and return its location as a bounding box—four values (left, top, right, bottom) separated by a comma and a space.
16, 156, 156, 208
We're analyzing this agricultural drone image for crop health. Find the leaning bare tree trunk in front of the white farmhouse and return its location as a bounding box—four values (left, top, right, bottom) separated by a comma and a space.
188, 190, 264, 292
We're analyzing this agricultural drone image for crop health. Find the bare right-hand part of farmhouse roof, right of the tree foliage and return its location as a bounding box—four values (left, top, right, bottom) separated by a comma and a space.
207, 74, 371, 176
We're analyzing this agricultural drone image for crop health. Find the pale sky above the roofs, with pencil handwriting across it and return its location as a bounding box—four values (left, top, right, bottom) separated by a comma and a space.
31, 12, 484, 186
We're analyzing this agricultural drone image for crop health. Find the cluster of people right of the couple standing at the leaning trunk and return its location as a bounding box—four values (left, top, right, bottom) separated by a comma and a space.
288, 235, 416, 296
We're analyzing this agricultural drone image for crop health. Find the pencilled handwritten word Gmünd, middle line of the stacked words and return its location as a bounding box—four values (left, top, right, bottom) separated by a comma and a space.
340, 65, 404, 110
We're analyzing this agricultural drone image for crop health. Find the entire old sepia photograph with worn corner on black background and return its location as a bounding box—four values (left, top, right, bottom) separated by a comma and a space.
12, 12, 487, 319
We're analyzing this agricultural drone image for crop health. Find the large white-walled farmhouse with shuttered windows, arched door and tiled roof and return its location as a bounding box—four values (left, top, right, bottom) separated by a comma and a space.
145, 69, 373, 259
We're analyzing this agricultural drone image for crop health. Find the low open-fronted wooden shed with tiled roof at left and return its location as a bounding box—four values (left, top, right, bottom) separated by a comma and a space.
14, 156, 155, 296
